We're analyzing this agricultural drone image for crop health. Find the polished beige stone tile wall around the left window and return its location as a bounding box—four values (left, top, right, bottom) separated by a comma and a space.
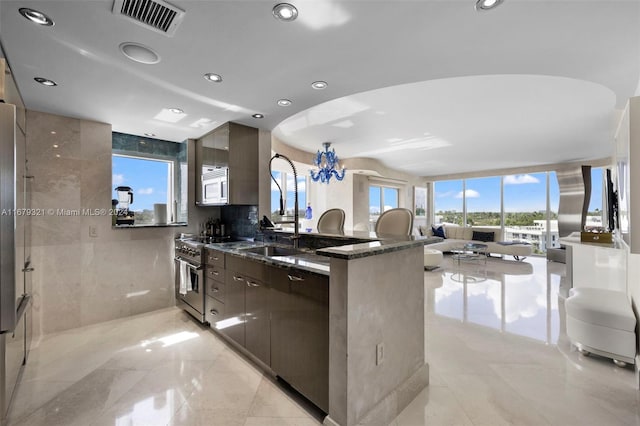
27, 111, 190, 336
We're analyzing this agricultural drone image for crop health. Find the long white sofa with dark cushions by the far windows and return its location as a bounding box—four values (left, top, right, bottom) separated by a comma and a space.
423, 225, 533, 260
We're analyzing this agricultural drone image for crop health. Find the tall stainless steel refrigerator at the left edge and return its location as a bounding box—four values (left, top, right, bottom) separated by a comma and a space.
0, 97, 33, 424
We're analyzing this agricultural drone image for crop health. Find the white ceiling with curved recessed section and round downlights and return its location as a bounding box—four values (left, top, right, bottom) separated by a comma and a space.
0, 0, 640, 176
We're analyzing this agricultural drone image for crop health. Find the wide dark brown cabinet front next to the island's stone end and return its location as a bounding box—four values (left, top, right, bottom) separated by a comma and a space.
270, 267, 329, 412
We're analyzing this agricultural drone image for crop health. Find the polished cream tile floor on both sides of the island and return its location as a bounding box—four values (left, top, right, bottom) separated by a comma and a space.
9, 256, 640, 426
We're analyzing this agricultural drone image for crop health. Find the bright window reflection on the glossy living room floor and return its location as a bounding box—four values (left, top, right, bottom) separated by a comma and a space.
426, 256, 565, 344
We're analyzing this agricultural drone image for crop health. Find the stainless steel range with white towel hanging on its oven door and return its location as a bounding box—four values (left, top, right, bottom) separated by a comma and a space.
174, 239, 206, 324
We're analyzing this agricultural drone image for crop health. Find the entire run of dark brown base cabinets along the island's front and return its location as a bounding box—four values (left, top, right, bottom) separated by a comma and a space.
205, 250, 329, 412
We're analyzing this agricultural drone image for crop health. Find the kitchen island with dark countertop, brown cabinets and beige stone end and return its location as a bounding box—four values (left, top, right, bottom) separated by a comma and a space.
201, 231, 436, 426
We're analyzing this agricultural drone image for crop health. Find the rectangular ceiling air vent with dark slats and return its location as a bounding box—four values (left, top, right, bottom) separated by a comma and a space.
113, 0, 184, 37
